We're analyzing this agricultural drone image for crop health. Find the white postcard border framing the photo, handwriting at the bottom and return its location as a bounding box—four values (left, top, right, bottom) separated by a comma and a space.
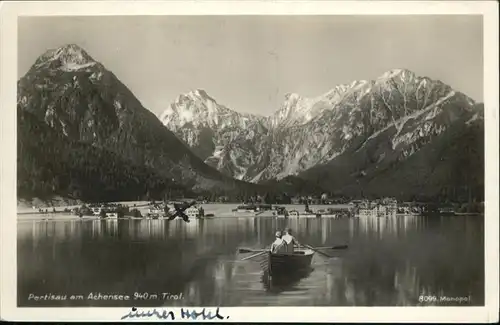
0, 1, 499, 322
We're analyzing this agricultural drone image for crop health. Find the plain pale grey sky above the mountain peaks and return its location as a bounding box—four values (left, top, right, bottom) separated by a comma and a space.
18, 15, 483, 115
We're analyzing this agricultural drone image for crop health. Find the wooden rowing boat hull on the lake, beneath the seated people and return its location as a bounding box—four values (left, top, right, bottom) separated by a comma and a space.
261, 248, 314, 276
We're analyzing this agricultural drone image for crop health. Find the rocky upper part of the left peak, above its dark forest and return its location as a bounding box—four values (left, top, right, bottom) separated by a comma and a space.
18, 45, 256, 197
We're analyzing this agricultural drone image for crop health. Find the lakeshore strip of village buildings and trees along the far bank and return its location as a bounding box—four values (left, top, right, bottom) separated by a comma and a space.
20, 190, 484, 220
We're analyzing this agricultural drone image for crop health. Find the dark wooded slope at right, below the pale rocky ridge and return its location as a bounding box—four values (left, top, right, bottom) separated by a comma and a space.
299, 105, 485, 201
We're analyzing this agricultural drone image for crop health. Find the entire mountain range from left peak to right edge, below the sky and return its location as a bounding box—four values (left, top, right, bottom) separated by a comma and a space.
18, 44, 484, 202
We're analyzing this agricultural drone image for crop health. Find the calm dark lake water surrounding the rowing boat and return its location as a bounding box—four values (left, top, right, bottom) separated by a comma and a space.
17, 206, 484, 307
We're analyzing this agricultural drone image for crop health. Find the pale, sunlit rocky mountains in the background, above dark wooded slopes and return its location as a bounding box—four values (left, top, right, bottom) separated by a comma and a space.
161, 69, 477, 190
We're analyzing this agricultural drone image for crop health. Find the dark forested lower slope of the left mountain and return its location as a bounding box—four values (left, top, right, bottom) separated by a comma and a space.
17, 110, 191, 202
